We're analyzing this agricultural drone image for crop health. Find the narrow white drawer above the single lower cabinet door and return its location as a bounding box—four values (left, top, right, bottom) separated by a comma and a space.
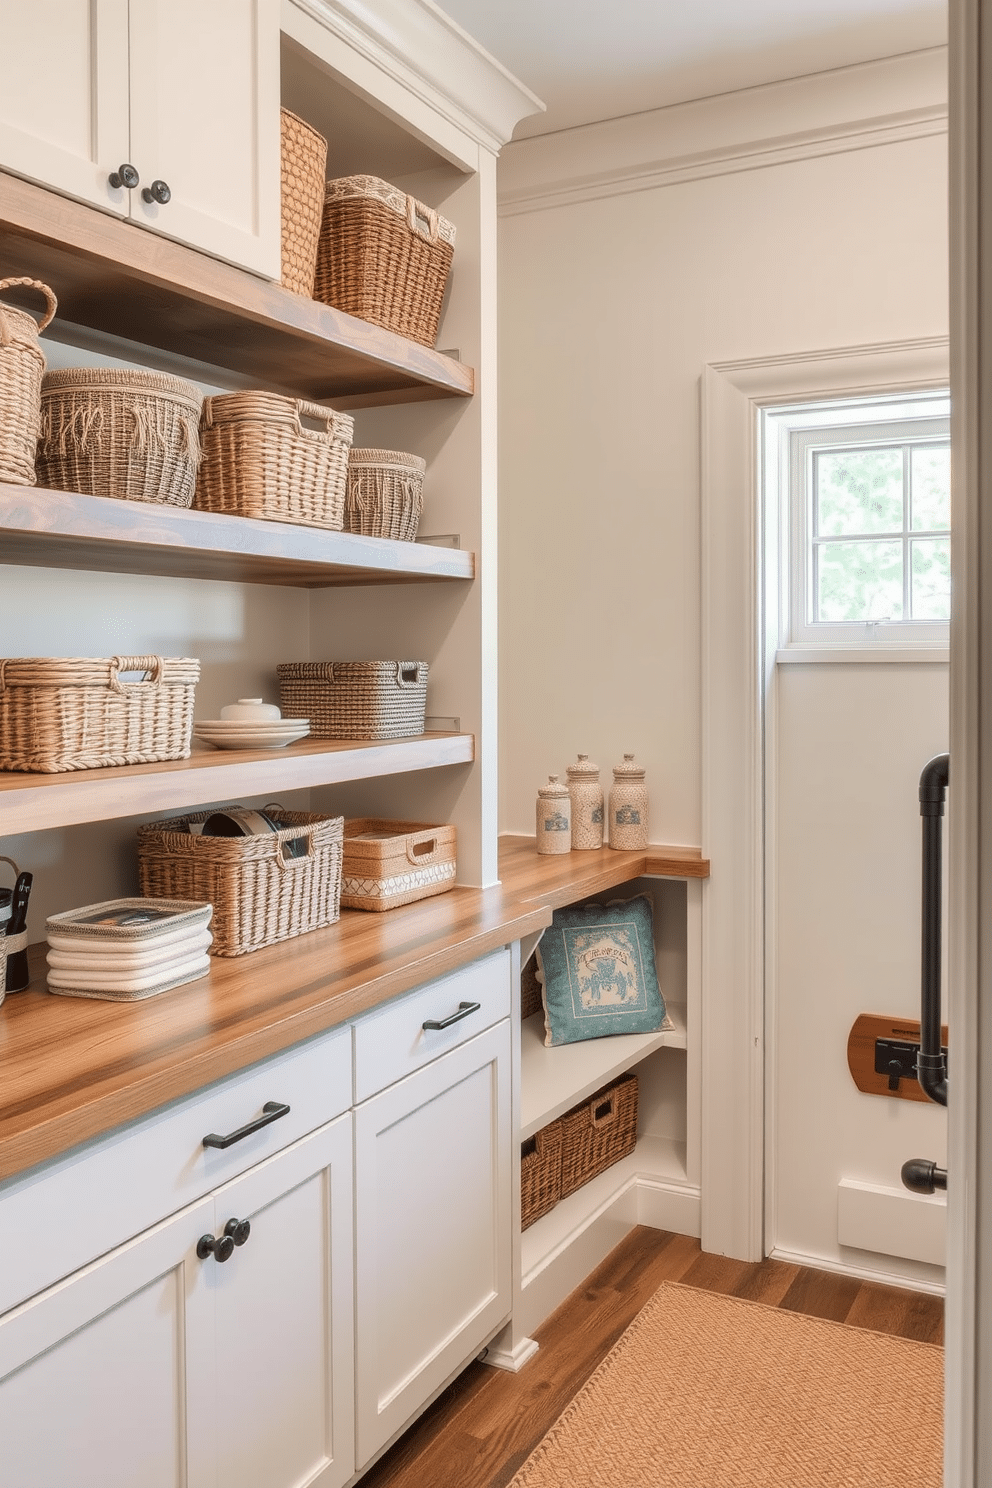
354, 951, 510, 1101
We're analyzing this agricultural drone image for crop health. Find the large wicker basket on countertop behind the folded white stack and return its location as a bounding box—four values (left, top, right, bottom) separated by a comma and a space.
138, 809, 344, 955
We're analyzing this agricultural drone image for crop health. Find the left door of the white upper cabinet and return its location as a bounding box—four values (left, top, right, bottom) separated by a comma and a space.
0, 0, 129, 216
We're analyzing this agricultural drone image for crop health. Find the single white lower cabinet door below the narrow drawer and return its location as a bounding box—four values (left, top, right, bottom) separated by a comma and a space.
355, 1019, 510, 1467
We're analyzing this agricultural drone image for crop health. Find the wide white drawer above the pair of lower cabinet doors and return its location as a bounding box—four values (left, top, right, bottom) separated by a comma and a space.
0, 1027, 351, 1312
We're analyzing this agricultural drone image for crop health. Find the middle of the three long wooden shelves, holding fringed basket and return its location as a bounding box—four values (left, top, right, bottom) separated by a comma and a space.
0, 484, 476, 589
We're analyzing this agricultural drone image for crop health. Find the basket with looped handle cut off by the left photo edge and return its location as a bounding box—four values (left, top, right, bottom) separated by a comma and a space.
0, 278, 57, 485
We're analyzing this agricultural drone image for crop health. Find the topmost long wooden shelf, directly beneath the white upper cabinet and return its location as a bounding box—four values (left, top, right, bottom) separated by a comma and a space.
0, 171, 474, 408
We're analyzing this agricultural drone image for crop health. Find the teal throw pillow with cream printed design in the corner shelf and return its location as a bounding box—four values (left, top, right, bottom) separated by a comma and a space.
537, 894, 674, 1048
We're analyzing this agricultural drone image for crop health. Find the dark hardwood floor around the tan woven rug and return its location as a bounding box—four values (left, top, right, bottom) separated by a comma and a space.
361, 1226, 943, 1488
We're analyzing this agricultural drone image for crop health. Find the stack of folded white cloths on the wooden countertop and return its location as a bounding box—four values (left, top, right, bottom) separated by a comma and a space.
46, 899, 214, 1003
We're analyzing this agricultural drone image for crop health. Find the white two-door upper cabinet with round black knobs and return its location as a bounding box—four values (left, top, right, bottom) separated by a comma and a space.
0, 0, 280, 278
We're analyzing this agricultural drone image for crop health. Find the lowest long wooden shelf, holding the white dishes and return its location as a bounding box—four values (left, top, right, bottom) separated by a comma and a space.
0, 734, 474, 835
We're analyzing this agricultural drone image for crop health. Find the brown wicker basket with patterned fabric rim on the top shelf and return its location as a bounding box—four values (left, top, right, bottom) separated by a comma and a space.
314, 176, 455, 347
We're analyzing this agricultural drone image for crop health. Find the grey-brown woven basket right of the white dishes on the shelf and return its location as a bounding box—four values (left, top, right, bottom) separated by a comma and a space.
275, 661, 428, 740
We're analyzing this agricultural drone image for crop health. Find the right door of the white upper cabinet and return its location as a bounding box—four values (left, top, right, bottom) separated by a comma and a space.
129, 0, 280, 280
